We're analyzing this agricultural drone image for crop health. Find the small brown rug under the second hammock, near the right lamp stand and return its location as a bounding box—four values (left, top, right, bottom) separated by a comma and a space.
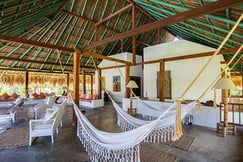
165, 135, 195, 151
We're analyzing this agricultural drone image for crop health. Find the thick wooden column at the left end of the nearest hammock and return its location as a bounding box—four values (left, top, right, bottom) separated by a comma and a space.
72, 50, 80, 127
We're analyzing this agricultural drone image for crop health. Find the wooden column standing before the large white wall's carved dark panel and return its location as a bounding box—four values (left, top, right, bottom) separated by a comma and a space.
159, 59, 165, 101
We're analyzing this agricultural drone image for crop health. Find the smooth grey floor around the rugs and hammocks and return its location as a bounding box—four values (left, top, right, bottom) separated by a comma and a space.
0, 104, 243, 162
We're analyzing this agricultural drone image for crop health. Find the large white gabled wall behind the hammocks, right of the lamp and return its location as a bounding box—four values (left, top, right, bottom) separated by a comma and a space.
144, 40, 221, 101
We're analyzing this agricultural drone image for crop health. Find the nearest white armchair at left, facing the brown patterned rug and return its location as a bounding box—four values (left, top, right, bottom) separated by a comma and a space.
29, 101, 66, 146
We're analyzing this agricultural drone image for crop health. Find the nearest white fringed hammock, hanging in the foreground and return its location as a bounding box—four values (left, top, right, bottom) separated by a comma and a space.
71, 95, 177, 162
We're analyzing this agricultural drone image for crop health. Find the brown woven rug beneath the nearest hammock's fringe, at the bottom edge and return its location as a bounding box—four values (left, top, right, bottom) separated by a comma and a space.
140, 145, 179, 162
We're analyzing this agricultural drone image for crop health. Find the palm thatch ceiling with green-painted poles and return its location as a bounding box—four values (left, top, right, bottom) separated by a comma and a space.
0, 0, 243, 72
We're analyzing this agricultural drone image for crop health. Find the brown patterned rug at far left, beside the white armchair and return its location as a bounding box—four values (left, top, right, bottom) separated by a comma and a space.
0, 127, 29, 149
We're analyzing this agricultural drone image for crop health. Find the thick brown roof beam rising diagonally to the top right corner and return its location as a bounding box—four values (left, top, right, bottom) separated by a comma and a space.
81, 0, 243, 51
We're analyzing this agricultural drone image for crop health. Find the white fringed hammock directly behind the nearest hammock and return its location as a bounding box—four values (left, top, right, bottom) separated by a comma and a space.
108, 93, 196, 143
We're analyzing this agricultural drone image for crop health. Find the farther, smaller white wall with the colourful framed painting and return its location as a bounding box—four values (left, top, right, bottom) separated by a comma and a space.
95, 52, 143, 102
